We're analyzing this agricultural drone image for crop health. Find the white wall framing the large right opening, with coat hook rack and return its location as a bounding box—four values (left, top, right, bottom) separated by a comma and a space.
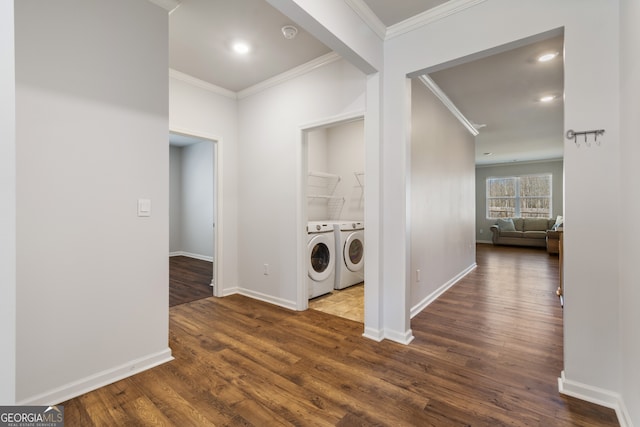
382, 0, 621, 416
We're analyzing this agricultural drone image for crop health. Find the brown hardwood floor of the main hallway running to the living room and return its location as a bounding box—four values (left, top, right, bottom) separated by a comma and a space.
63, 245, 618, 426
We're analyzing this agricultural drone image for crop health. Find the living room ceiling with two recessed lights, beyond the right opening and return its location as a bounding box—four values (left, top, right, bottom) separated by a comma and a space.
429, 36, 564, 165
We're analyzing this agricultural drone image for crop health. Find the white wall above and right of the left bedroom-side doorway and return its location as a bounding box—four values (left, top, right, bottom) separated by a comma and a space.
169, 73, 240, 295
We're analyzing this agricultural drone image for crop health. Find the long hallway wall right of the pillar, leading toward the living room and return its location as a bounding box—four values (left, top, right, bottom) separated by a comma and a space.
410, 79, 476, 314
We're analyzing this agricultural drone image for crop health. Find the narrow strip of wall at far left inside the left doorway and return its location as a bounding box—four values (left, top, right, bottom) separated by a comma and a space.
169, 145, 183, 253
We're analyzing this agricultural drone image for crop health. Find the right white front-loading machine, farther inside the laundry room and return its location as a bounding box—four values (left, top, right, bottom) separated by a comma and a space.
334, 221, 364, 289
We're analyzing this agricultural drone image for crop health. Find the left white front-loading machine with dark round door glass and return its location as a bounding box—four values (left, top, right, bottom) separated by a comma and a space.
307, 221, 336, 299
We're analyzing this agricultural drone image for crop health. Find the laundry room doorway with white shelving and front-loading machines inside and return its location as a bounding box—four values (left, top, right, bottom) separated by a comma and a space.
303, 116, 365, 323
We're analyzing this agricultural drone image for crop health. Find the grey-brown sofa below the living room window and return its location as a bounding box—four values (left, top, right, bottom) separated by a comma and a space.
491, 218, 557, 248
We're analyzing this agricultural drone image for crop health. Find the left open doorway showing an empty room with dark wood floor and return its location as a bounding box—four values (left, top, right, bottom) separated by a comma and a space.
169, 132, 217, 306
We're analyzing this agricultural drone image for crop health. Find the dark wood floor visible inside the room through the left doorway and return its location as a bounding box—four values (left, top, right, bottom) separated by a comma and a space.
169, 256, 213, 307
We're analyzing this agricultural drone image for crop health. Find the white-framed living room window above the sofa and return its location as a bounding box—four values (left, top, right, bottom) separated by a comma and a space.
487, 175, 551, 218
